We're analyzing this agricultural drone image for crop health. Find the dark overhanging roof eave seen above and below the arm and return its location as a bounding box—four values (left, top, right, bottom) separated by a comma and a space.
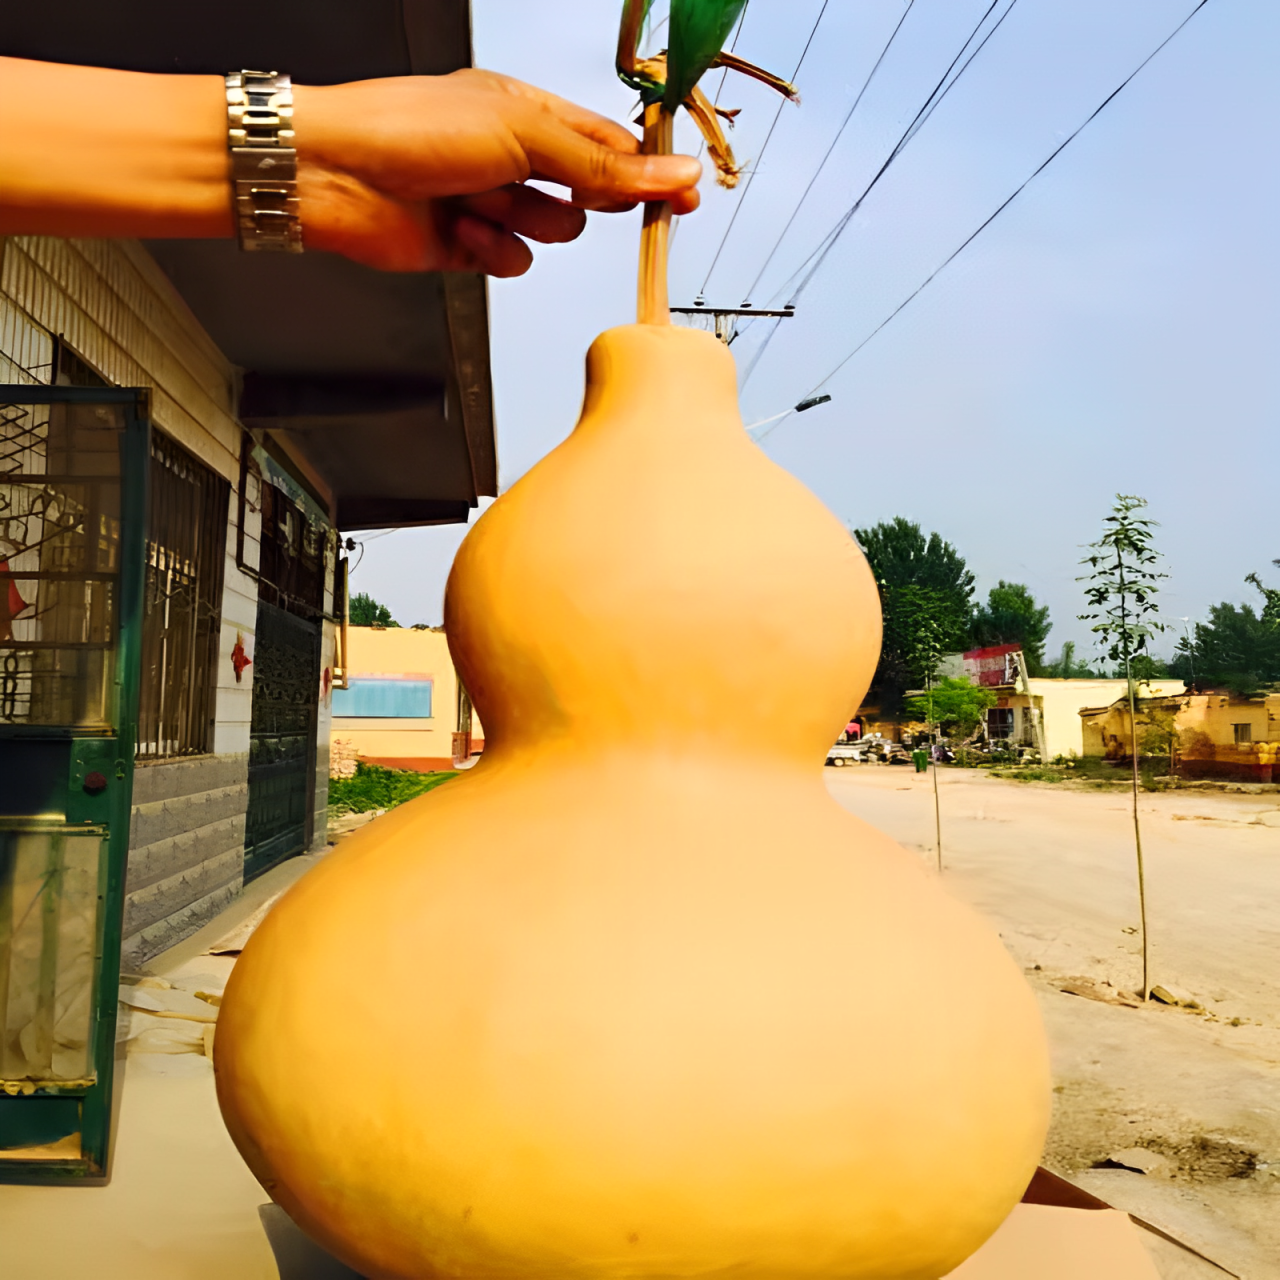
0, 0, 498, 530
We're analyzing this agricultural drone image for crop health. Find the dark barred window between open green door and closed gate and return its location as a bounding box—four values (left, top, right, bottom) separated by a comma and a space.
137, 430, 230, 759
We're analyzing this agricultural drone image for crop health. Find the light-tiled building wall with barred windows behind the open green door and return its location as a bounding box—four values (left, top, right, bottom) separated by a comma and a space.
0, 237, 342, 966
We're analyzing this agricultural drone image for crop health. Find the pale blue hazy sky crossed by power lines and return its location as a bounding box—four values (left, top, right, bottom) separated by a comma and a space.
352, 0, 1280, 653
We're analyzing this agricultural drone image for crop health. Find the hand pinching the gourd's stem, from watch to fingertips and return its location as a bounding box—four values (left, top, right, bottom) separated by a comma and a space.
293, 70, 701, 276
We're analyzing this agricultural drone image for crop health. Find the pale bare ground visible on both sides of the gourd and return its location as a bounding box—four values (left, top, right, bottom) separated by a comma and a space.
0, 765, 1280, 1280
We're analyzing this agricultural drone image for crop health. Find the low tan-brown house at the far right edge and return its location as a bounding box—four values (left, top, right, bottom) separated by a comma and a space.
1080, 690, 1280, 782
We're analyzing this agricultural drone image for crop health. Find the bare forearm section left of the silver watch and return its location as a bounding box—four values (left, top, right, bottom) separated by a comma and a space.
0, 58, 234, 238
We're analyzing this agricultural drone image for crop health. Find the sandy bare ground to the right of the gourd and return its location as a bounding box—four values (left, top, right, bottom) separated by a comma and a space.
827, 765, 1280, 1280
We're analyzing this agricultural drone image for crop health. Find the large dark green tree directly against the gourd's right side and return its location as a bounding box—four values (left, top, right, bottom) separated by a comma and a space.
854, 516, 973, 712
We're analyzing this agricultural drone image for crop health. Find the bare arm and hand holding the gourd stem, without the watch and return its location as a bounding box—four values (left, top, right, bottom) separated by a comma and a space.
0, 58, 701, 275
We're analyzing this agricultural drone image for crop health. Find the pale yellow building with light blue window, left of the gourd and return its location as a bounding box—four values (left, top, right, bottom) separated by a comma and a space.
330, 627, 484, 773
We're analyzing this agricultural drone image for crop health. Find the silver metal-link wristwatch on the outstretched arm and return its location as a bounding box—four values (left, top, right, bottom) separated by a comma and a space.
227, 72, 302, 253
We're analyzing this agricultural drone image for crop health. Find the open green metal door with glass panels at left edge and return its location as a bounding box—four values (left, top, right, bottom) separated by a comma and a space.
0, 385, 150, 1183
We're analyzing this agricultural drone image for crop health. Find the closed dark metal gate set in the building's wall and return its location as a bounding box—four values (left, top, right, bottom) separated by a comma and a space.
244, 600, 320, 882
